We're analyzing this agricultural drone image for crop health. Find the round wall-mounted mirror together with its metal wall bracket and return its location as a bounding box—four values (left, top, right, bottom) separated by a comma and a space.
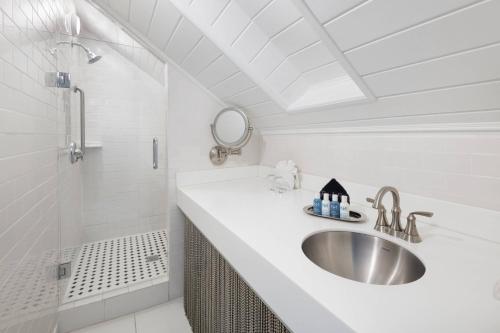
209, 107, 253, 165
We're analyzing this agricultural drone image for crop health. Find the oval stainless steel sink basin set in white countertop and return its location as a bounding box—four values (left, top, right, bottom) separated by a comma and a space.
302, 231, 425, 285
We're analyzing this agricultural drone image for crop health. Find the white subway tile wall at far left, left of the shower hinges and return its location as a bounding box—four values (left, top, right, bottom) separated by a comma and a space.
0, 0, 68, 333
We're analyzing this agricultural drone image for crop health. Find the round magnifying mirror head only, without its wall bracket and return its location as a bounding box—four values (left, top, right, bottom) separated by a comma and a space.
212, 108, 252, 148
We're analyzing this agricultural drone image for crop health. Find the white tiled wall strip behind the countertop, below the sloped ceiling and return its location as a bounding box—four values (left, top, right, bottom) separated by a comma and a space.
262, 133, 500, 210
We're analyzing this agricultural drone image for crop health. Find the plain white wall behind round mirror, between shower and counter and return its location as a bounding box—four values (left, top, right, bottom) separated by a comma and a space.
167, 65, 260, 298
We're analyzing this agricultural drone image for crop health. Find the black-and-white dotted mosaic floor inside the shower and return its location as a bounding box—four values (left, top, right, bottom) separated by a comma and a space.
63, 230, 168, 302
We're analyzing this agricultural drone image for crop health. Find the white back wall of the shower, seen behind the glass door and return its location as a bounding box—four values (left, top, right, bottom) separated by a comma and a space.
72, 38, 167, 242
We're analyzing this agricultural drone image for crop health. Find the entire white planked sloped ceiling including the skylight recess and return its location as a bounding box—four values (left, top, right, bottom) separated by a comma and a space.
82, 0, 500, 127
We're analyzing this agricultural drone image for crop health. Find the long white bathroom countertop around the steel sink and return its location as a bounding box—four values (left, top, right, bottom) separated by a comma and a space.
177, 167, 500, 333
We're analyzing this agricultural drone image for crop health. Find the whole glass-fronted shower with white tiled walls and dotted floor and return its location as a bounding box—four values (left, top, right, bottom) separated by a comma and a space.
0, 0, 168, 333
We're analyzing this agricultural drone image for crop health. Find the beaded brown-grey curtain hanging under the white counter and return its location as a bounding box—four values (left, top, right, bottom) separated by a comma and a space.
184, 219, 290, 333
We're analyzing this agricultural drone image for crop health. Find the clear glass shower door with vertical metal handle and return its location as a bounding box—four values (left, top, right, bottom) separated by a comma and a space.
56, 30, 168, 314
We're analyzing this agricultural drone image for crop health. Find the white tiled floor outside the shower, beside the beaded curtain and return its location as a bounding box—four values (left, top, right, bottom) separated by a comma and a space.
73, 298, 192, 333
